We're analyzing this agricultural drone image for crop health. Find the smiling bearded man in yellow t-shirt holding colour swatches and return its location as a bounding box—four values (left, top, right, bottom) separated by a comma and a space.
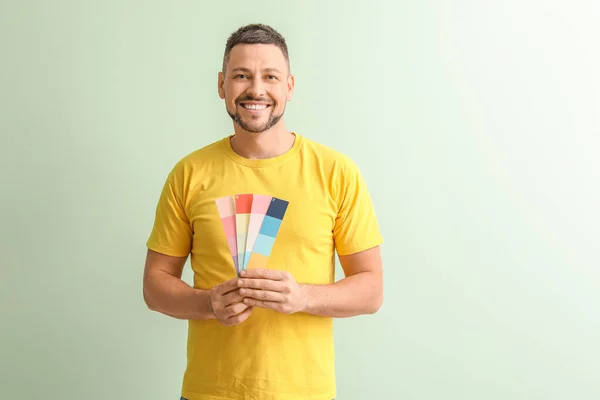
144, 24, 383, 400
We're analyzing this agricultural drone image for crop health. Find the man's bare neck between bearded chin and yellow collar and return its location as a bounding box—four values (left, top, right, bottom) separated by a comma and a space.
231, 126, 295, 159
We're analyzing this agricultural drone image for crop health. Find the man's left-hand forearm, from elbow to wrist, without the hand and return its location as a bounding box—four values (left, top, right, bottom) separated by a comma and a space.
144, 271, 216, 320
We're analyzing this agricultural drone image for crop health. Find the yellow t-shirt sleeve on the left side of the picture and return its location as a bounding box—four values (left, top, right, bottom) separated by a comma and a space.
146, 167, 192, 257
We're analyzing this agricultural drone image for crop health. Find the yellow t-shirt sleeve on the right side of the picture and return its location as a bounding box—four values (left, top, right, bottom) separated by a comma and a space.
333, 162, 383, 255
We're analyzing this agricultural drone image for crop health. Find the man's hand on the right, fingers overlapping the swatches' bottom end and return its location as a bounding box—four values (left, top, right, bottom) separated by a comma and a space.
238, 268, 306, 314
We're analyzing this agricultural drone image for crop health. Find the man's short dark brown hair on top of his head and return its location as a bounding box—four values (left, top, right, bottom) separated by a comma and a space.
223, 24, 290, 73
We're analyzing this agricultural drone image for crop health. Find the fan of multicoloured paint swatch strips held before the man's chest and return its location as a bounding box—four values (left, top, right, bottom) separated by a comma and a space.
216, 194, 289, 275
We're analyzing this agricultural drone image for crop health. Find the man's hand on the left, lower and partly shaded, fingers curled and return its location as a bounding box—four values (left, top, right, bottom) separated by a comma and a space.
210, 278, 253, 326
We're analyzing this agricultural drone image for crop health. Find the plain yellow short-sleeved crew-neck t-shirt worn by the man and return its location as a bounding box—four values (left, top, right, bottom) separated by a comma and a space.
147, 133, 382, 400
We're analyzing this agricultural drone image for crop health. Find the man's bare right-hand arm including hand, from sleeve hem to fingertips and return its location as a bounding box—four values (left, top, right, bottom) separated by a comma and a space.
239, 246, 383, 318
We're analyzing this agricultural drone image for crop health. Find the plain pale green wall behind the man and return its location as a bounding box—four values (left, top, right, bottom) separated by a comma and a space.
0, 0, 600, 400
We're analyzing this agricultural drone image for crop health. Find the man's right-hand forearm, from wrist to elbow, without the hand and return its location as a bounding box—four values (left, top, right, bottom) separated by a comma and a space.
300, 272, 383, 318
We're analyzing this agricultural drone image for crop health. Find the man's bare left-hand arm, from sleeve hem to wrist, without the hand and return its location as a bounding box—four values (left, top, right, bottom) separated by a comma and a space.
144, 250, 215, 320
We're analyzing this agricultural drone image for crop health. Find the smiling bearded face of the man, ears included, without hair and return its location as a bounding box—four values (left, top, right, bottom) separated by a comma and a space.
219, 44, 294, 132
